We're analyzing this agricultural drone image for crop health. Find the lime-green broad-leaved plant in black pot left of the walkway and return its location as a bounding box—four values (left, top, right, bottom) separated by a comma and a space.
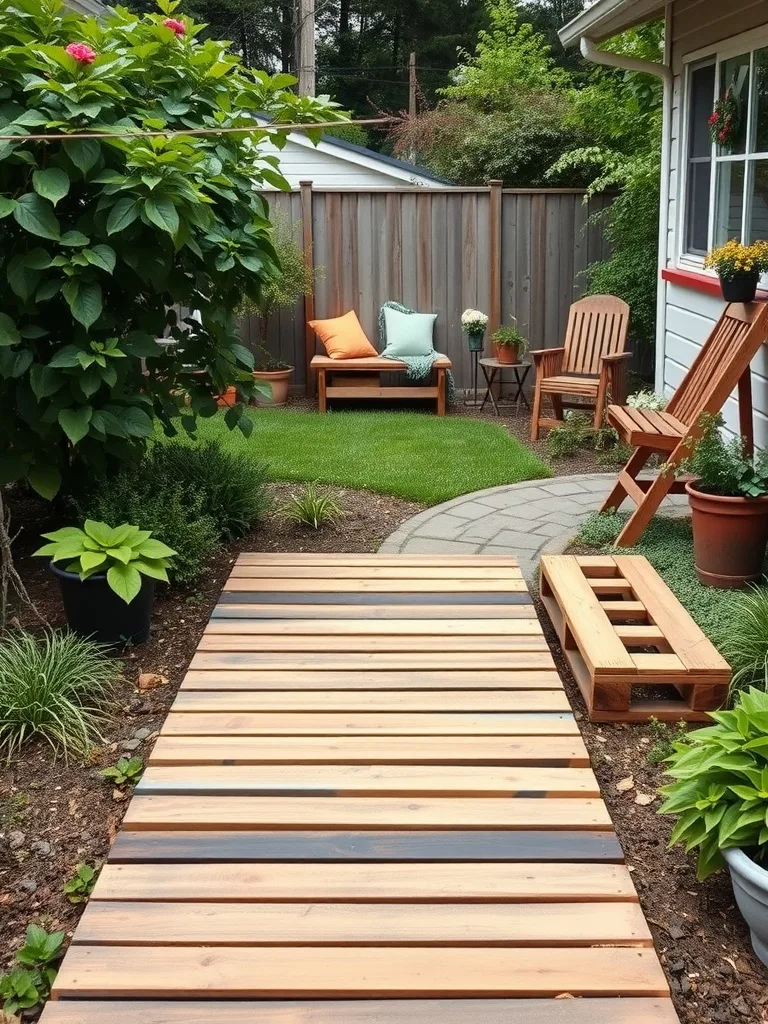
35, 519, 176, 644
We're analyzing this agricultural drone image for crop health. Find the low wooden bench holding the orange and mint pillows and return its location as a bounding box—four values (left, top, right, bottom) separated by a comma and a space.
309, 355, 451, 416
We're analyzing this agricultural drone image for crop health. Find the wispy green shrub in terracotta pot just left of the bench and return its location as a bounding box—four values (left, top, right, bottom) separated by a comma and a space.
238, 218, 317, 406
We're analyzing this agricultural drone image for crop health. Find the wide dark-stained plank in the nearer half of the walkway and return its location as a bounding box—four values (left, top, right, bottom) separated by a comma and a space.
110, 829, 624, 865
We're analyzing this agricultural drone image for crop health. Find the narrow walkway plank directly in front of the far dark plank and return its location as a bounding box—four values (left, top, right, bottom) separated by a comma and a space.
211, 594, 536, 626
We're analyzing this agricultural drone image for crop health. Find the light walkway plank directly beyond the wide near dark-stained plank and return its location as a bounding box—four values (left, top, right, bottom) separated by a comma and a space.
123, 794, 610, 831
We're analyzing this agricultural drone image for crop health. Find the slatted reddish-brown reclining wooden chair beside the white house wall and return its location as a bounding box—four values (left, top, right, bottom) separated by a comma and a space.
600, 302, 768, 547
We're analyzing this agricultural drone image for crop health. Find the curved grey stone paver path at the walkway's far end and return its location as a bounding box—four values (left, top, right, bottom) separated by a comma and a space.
379, 473, 687, 580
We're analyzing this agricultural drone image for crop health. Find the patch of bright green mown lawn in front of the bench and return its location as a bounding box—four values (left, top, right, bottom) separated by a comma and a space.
192, 410, 551, 505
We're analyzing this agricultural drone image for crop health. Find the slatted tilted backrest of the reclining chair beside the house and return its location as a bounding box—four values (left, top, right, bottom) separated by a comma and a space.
667, 302, 768, 427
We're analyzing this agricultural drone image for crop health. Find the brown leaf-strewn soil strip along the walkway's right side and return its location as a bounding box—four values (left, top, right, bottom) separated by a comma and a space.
538, 593, 768, 1024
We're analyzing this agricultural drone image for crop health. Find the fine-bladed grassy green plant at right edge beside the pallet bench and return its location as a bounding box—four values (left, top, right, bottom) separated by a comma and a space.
720, 587, 768, 691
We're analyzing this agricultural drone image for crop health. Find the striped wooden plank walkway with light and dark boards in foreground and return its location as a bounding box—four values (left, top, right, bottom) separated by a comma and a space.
42, 554, 678, 1024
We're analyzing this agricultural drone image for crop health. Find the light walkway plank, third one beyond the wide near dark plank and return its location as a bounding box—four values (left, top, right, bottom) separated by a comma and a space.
152, 733, 590, 768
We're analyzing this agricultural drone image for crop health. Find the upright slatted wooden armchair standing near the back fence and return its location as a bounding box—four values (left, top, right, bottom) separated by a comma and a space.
530, 295, 632, 441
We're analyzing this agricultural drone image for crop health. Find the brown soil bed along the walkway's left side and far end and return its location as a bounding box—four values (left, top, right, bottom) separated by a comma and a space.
0, 484, 422, 1007
